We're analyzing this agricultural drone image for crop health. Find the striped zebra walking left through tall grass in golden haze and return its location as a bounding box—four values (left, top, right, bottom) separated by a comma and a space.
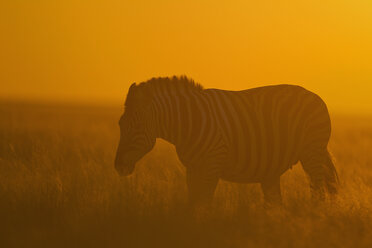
115, 76, 338, 206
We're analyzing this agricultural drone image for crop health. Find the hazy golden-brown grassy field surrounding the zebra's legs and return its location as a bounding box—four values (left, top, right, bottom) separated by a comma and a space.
0, 103, 372, 247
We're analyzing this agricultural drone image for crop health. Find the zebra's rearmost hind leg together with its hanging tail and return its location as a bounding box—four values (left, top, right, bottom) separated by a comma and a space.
300, 148, 338, 200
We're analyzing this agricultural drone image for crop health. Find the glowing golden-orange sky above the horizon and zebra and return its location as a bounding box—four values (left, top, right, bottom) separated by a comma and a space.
0, 0, 372, 113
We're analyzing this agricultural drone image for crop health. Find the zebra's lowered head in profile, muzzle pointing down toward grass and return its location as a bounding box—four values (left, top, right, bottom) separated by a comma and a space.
115, 83, 156, 176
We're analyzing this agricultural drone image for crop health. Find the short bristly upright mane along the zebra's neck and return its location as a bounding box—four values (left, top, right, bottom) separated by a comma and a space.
125, 76, 204, 107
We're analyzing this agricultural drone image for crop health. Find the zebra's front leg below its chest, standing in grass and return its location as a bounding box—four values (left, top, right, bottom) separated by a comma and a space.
186, 169, 219, 212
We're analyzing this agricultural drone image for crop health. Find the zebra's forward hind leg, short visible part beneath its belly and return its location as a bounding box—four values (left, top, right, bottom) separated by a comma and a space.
261, 176, 282, 207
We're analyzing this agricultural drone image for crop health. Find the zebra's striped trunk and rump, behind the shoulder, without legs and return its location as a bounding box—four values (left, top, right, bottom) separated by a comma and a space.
205, 85, 331, 182
